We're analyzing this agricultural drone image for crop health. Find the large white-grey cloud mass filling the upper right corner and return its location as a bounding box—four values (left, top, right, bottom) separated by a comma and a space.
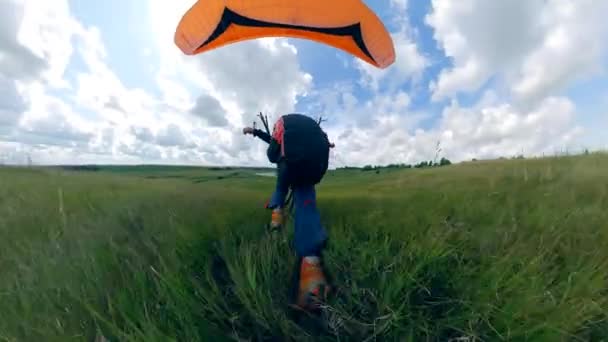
426, 0, 608, 103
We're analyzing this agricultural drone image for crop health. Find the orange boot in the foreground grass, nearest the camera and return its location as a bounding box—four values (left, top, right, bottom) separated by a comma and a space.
297, 256, 329, 311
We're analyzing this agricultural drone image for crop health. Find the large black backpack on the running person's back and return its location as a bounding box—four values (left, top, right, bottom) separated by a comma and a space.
282, 114, 330, 185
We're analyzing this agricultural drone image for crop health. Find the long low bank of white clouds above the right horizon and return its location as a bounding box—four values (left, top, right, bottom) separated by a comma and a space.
332, 96, 581, 166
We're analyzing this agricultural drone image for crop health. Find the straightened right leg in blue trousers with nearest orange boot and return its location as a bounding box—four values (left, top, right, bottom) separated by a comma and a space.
294, 186, 328, 310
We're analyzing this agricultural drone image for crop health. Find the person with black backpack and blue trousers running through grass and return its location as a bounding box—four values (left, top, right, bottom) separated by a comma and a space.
243, 114, 333, 310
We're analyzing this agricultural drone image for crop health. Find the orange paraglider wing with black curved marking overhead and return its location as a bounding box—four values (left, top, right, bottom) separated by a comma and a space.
175, 0, 395, 69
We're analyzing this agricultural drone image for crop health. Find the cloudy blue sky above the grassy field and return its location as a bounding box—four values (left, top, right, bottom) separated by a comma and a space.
0, 0, 608, 167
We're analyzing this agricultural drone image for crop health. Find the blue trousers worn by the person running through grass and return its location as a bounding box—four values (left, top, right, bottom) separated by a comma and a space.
268, 166, 327, 257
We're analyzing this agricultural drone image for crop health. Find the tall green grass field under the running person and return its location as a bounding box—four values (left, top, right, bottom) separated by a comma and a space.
0, 154, 608, 341
